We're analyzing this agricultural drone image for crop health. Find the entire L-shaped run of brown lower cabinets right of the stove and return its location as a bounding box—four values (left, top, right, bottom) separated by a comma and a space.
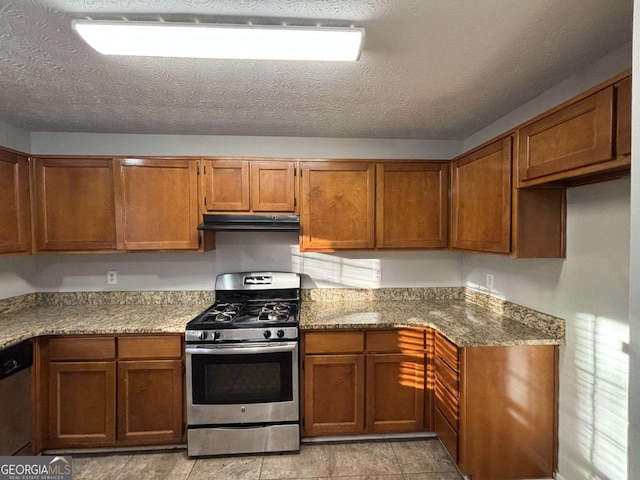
302, 329, 558, 480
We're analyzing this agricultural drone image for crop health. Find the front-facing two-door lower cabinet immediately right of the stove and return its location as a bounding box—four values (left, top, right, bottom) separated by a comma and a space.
303, 329, 430, 436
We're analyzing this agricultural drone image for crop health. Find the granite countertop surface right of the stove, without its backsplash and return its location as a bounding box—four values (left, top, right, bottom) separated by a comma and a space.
300, 300, 564, 347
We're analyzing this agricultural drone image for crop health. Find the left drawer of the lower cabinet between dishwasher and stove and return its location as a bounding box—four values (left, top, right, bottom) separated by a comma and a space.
48, 337, 116, 362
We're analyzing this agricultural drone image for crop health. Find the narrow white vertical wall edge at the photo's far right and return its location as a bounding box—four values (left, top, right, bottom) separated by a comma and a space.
629, 4, 640, 480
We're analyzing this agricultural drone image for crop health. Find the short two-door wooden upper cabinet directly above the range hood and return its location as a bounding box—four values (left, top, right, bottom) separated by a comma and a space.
201, 158, 296, 213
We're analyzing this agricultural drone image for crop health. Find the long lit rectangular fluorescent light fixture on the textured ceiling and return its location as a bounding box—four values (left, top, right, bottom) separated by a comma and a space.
73, 20, 364, 61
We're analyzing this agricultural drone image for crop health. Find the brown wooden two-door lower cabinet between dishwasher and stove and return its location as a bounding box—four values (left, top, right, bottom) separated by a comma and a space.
36, 335, 184, 449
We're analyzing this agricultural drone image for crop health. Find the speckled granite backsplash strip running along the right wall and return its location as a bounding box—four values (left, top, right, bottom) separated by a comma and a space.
465, 288, 566, 339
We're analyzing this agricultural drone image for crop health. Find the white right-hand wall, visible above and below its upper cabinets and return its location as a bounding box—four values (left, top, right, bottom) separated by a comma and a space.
462, 44, 637, 480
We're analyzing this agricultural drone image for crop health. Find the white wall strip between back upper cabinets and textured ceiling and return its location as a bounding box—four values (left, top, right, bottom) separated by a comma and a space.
30, 132, 462, 159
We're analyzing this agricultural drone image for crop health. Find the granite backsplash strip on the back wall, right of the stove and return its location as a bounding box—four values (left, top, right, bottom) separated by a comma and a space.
301, 287, 465, 302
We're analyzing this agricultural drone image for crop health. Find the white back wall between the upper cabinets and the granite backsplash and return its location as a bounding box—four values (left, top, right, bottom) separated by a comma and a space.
25, 233, 462, 291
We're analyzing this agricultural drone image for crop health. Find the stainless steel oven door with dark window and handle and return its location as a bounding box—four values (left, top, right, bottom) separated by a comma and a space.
185, 342, 300, 426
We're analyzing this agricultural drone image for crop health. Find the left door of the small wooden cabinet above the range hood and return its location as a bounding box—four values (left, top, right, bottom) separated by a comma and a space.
202, 160, 249, 213
